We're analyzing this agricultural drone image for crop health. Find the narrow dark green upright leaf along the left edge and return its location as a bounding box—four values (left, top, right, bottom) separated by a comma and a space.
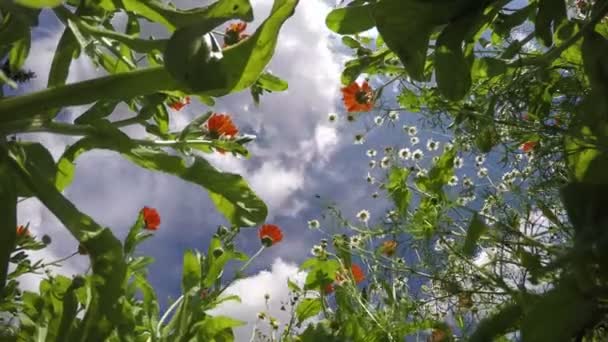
0, 145, 17, 293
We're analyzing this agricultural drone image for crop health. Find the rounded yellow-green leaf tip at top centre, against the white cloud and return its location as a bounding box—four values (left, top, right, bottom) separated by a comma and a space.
325, 4, 376, 34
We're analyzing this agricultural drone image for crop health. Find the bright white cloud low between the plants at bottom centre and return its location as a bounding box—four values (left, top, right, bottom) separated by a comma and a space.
209, 258, 306, 341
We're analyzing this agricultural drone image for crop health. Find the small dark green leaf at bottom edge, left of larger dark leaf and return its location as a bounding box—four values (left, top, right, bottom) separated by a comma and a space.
469, 304, 522, 342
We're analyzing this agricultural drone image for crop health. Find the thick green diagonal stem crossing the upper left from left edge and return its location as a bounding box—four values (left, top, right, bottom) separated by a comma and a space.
0, 66, 178, 124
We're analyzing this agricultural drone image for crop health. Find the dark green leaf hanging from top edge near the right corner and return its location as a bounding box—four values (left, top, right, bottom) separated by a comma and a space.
534, 0, 568, 46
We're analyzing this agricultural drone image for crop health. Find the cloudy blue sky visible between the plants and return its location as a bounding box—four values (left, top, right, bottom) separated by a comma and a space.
8, 0, 528, 341
